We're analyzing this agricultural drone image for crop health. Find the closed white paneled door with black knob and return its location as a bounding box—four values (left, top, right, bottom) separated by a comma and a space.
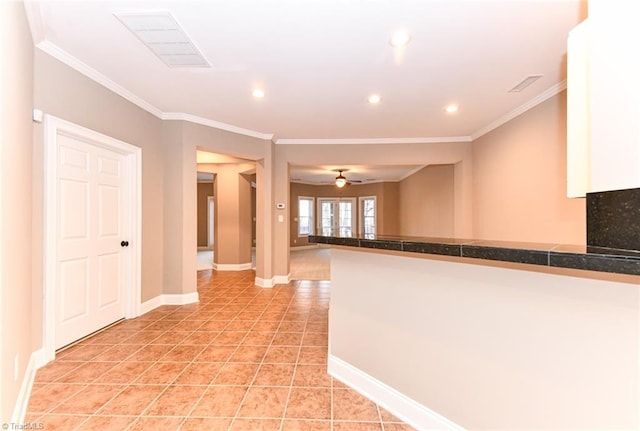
55, 135, 132, 349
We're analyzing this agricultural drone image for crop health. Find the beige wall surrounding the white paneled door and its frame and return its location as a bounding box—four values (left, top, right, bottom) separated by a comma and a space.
33, 50, 165, 306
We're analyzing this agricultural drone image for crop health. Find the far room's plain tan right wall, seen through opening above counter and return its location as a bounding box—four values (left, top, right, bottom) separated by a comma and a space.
398, 165, 455, 238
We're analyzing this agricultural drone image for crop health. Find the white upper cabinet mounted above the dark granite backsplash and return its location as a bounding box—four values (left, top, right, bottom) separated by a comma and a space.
567, 0, 640, 192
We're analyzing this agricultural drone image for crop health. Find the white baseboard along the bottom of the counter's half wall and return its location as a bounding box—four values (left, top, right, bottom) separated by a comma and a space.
328, 355, 464, 431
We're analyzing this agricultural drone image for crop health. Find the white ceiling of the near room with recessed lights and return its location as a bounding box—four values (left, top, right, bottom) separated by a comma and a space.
27, 0, 586, 143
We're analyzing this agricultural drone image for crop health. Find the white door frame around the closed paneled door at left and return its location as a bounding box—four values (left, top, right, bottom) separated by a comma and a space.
42, 115, 142, 363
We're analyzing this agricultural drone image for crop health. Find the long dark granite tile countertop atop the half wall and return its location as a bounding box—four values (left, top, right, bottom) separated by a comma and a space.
309, 235, 640, 275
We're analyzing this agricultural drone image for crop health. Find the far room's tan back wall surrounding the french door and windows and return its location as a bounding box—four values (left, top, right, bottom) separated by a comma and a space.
289, 183, 398, 247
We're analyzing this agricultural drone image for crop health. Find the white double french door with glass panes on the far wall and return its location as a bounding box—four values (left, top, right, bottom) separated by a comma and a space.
318, 198, 356, 237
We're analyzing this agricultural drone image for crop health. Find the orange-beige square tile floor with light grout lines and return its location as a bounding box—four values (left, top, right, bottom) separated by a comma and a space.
26, 271, 413, 431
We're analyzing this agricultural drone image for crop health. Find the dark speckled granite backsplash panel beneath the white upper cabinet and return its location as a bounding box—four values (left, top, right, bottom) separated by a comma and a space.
587, 189, 640, 250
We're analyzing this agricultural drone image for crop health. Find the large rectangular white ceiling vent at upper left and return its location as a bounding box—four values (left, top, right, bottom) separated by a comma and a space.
114, 12, 211, 67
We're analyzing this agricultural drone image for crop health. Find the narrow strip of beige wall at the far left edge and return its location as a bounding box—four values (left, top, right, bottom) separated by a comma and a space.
0, 2, 33, 423
